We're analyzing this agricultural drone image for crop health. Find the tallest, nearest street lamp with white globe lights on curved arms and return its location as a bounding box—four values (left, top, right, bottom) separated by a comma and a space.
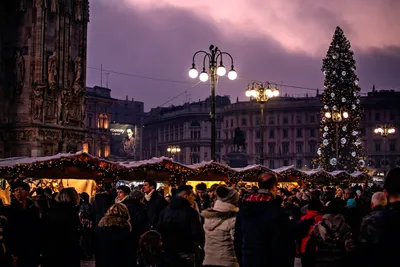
189, 45, 237, 161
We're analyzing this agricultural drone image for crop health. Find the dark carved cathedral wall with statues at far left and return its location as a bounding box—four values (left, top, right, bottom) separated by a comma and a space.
0, 0, 89, 157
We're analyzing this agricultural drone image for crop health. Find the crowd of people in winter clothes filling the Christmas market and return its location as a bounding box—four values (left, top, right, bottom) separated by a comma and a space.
0, 168, 400, 267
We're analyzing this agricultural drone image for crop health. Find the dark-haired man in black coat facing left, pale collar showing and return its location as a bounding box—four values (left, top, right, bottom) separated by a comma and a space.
143, 179, 168, 229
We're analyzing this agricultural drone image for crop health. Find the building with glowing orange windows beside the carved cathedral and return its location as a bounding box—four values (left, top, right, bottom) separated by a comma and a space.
83, 86, 118, 158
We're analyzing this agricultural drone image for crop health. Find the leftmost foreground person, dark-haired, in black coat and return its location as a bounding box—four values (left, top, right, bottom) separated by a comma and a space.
5, 181, 42, 267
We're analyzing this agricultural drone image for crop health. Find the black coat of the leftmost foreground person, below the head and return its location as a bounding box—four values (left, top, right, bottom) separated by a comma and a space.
6, 199, 42, 266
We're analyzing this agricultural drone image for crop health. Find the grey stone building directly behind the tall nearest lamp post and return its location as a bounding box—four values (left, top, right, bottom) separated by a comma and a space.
142, 96, 230, 164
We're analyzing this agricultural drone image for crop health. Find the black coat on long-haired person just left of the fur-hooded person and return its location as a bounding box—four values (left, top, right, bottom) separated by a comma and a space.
43, 202, 83, 267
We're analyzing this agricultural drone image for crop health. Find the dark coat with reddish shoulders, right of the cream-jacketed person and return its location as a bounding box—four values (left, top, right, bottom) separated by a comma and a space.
234, 189, 294, 267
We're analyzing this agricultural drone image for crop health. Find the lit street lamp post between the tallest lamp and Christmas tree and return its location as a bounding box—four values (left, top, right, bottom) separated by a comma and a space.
246, 82, 279, 165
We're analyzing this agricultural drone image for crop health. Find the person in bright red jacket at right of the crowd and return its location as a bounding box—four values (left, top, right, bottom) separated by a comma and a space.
296, 199, 323, 267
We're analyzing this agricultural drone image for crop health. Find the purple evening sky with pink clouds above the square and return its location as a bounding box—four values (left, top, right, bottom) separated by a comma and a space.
87, 0, 400, 110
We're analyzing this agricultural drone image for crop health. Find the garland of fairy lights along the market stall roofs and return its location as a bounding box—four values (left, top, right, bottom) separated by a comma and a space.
0, 153, 369, 185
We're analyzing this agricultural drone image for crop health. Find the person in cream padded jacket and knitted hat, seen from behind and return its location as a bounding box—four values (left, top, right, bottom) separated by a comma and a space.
201, 186, 239, 267
